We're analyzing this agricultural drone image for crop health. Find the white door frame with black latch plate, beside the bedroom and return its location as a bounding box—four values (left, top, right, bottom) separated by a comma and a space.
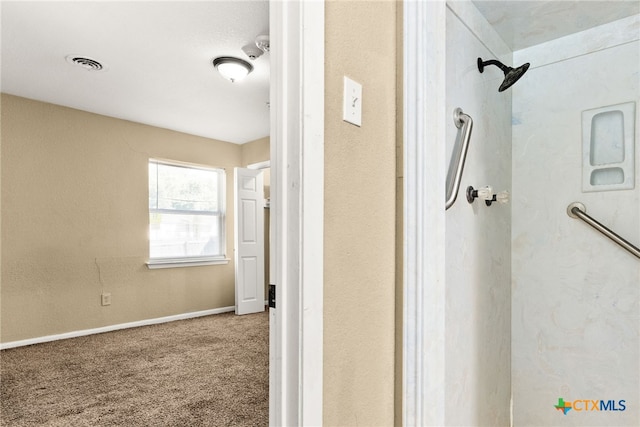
269, 0, 324, 426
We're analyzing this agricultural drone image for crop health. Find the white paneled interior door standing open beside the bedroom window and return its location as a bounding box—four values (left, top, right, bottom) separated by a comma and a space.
233, 168, 265, 314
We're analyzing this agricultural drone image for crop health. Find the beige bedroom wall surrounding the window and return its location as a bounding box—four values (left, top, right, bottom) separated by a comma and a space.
1, 94, 242, 342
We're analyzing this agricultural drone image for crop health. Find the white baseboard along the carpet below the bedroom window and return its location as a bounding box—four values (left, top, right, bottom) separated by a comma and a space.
0, 306, 236, 350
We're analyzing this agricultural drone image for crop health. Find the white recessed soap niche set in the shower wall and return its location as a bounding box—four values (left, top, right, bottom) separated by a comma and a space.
582, 102, 635, 192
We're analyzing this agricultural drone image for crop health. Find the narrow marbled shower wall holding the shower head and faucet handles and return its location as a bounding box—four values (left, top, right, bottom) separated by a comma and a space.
443, 2, 512, 426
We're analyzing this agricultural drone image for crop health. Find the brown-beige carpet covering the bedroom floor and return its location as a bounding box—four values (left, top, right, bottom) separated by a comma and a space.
0, 312, 269, 427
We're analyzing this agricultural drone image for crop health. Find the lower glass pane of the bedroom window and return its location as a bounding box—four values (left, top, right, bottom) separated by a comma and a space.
149, 212, 224, 258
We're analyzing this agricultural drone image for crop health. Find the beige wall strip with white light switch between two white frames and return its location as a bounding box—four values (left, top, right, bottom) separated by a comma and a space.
323, 1, 396, 426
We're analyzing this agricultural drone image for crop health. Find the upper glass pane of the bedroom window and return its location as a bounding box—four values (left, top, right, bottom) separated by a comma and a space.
154, 163, 219, 211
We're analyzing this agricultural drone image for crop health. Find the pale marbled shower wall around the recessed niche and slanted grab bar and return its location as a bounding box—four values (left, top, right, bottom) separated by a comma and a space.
511, 15, 640, 427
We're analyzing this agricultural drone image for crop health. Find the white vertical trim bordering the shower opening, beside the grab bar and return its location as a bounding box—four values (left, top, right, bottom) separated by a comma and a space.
402, 0, 450, 426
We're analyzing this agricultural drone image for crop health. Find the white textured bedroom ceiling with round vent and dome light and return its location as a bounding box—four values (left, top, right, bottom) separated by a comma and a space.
1, 0, 269, 143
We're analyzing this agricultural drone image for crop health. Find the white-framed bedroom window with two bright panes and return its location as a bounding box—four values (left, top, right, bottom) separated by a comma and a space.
148, 159, 227, 268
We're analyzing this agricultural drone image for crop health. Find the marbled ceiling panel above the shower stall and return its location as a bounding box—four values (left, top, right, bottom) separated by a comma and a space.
473, 0, 640, 51
